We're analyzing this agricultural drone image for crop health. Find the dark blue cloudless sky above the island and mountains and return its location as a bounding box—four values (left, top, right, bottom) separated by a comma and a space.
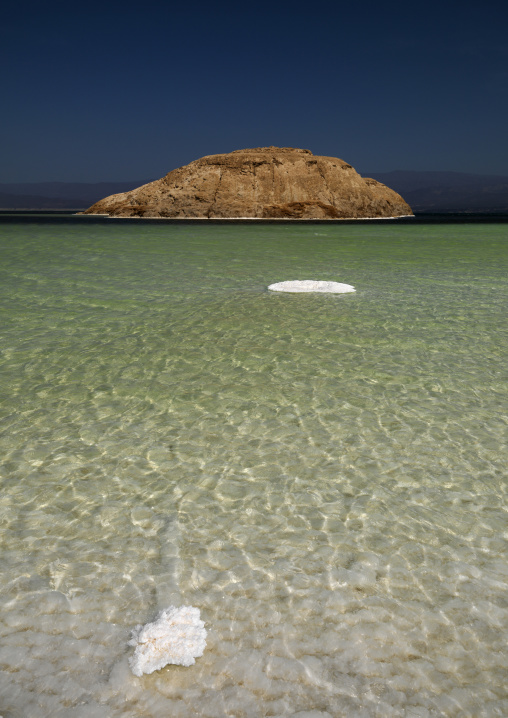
0, 0, 508, 182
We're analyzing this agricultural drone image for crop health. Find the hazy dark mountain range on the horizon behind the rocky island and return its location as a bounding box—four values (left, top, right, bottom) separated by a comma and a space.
0, 170, 508, 213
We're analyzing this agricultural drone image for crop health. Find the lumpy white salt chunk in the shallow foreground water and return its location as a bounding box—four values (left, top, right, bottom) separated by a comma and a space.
129, 606, 206, 676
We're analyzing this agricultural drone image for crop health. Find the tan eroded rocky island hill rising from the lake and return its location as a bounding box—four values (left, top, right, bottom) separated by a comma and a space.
83, 147, 413, 219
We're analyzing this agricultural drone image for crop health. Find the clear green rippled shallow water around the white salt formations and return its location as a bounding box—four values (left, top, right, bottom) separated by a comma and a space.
0, 218, 508, 718
